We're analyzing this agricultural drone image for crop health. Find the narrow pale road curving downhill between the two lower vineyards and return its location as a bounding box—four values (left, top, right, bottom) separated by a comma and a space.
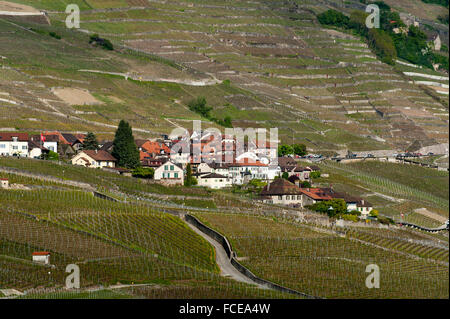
186, 223, 268, 289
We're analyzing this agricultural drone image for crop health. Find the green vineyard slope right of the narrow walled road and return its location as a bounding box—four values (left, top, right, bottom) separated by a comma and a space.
197, 214, 448, 298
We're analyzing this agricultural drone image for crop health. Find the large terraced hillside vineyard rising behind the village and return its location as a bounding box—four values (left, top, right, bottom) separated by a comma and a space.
0, 0, 448, 151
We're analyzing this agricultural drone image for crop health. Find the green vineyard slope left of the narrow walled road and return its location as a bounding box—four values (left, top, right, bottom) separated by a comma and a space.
0, 189, 292, 298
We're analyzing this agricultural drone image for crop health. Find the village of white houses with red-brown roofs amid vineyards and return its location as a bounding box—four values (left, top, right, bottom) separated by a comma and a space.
0, 125, 377, 221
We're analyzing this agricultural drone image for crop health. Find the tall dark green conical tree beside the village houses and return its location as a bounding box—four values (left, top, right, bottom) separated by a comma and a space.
112, 120, 141, 169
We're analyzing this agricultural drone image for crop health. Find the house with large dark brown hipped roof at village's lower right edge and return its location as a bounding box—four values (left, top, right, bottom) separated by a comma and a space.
260, 178, 303, 206
